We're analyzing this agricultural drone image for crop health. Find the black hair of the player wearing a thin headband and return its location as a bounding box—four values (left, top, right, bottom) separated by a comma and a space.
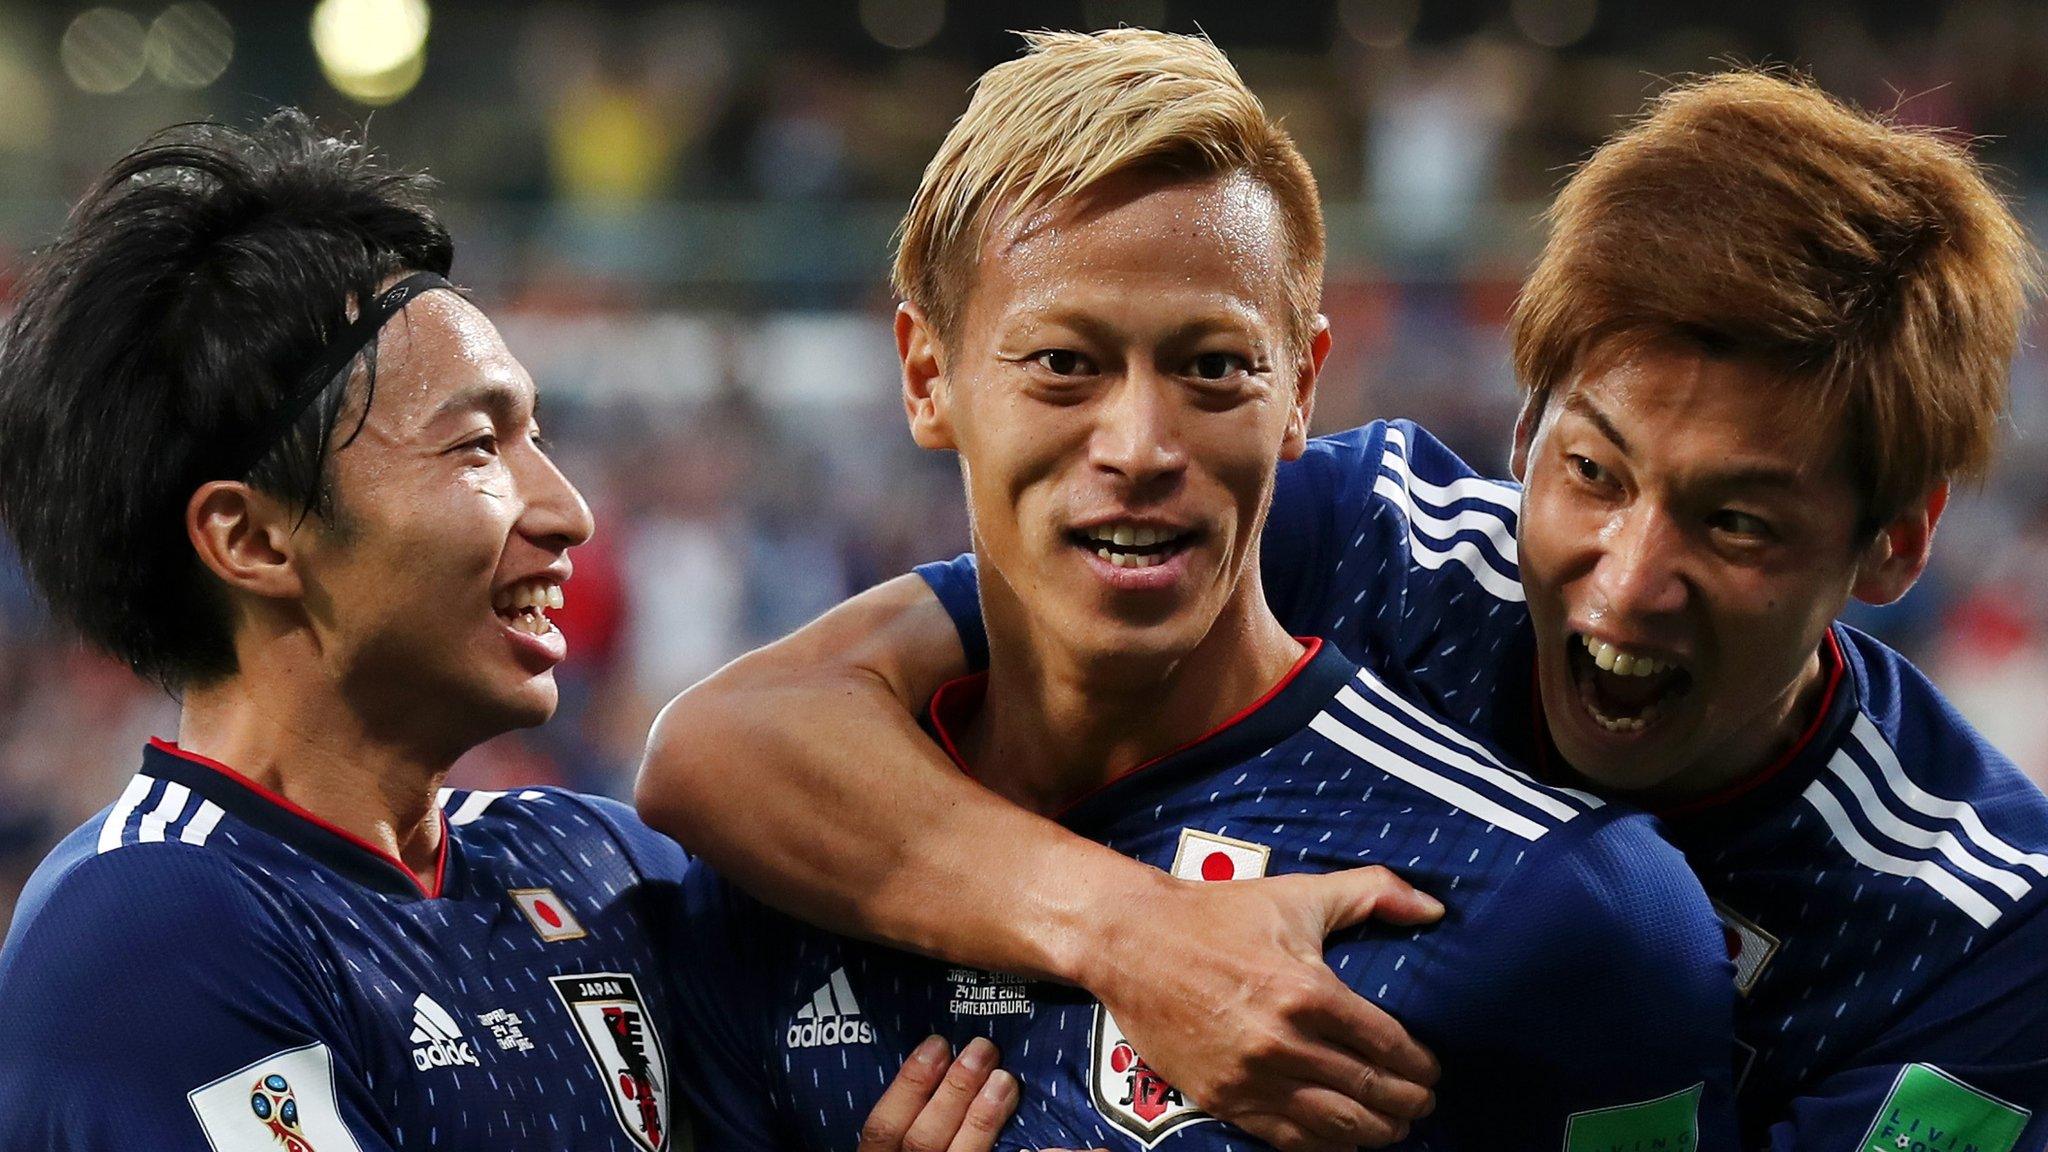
0, 109, 455, 691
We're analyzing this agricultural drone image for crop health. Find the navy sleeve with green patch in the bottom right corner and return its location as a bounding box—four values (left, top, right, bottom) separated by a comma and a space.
1765, 908, 2048, 1152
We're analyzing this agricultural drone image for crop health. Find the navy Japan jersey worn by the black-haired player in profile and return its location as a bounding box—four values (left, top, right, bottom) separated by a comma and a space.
0, 744, 686, 1152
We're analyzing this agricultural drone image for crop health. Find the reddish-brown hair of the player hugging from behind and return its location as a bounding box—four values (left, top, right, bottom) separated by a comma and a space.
1509, 72, 2036, 525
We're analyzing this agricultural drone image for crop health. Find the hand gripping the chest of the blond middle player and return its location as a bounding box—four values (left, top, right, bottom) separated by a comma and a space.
1081, 867, 1444, 1152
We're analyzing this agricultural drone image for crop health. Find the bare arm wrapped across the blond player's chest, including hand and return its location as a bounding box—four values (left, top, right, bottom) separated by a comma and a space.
637, 576, 1440, 1148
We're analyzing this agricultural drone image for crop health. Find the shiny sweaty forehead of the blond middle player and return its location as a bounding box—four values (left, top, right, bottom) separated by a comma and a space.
977, 174, 1286, 310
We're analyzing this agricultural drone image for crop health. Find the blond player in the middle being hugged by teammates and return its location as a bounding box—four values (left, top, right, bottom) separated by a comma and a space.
659, 31, 1735, 1150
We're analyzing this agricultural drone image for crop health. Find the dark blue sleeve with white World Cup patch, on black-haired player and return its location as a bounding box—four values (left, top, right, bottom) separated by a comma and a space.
0, 845, 393, 1152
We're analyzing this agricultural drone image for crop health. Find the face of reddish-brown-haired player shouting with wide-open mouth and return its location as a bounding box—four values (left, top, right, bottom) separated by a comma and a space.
1518, 348, 1908, 797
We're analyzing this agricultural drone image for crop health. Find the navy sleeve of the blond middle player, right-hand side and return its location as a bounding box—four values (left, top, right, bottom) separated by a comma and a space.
1421, 814, 1737, 1152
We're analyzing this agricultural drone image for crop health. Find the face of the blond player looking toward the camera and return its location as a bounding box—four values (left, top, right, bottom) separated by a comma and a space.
897, 174, 1329, 662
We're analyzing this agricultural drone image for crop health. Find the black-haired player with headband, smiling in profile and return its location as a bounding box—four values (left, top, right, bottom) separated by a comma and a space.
0, 113, 1016, 1152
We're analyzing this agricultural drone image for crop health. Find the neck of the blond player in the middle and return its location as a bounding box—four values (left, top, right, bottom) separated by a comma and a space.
961, 576, 1303, 814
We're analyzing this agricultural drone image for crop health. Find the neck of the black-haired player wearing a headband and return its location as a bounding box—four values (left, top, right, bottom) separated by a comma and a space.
178, 631, 461, 888
